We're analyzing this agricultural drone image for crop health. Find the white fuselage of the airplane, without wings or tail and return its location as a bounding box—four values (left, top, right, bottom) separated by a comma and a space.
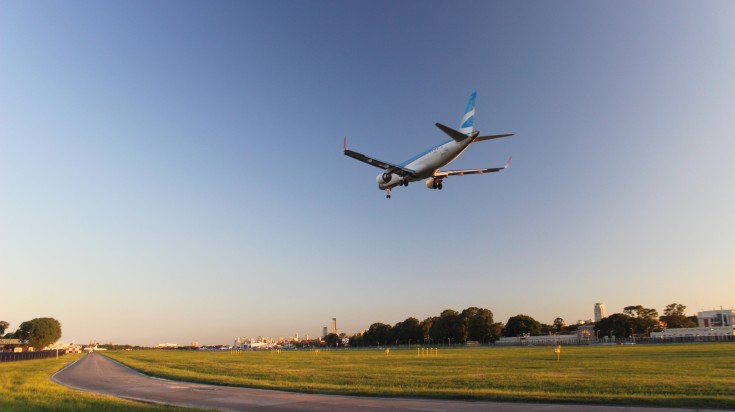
376, 137, 473, 190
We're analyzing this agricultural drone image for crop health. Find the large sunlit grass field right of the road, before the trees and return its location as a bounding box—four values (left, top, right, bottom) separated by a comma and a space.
107, 343, 735, 409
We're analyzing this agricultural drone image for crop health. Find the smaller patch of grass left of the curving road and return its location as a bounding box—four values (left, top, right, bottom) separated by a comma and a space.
0, 355, 191, 412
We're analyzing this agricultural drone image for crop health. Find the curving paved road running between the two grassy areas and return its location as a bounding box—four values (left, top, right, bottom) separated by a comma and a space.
52, 353, 720, 412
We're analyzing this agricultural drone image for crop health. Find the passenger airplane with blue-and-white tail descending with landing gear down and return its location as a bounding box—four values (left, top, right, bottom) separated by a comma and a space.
342, 92, 514, 199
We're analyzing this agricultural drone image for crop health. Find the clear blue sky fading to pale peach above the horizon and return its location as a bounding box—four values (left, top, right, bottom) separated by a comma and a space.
0, 1, 735, 344
